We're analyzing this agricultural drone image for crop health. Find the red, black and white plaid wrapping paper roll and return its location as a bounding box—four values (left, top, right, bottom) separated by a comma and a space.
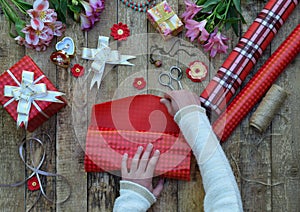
200, 0, 298, 115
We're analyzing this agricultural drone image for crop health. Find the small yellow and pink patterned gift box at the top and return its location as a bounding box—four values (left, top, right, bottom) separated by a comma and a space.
147, 1, 183, 40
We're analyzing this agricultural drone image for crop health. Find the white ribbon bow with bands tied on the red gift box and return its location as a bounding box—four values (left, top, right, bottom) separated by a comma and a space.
4, 70, 64, 129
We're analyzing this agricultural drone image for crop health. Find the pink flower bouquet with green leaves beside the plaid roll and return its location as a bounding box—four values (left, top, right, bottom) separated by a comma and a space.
181, 0, 245, 57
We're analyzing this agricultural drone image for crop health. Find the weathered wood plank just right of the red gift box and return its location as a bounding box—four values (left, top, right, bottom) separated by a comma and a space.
56, 20, 87, 211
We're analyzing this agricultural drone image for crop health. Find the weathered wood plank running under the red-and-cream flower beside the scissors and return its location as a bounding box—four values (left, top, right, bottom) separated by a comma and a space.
177, 0, 207, 211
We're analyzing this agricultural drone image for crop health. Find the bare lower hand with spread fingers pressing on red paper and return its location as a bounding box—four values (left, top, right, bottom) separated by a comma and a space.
121, 143, 163, 198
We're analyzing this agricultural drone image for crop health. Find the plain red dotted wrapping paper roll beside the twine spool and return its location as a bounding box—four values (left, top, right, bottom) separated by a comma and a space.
213, 25, 300, 141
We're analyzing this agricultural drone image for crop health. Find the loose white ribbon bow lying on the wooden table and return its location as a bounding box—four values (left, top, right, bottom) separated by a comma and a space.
82, 36, 136, 89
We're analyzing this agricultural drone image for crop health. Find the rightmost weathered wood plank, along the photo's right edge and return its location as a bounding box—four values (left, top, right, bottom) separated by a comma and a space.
271, 6, 300, 211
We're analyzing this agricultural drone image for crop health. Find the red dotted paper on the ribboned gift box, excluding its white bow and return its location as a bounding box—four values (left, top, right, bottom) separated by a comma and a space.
0, 56, 66, 132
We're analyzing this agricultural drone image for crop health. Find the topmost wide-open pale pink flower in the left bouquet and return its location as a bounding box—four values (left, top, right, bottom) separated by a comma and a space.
27, 0, 57, 29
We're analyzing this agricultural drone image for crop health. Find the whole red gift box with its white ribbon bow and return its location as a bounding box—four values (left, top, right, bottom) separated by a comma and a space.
0, 56, 66, 132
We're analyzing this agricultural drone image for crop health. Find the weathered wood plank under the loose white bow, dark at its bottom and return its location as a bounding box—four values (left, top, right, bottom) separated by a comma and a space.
87, 0, 119, 212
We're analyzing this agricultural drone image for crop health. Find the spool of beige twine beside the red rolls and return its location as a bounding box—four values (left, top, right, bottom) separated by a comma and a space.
250, 84, 287, 133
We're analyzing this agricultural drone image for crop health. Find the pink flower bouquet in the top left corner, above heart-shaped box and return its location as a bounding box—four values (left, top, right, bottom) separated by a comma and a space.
0, 0, 104, 51
